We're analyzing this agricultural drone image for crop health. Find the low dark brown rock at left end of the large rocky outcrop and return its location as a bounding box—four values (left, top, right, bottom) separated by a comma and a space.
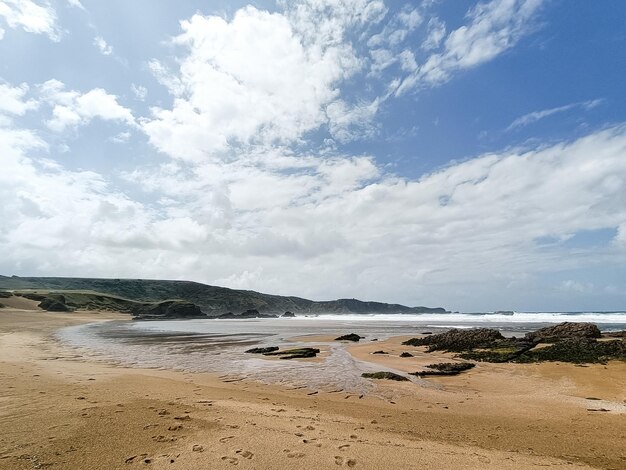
402, 328, 504, 352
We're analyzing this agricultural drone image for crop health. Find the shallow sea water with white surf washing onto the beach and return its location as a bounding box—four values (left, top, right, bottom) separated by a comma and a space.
57, 312, 626, 393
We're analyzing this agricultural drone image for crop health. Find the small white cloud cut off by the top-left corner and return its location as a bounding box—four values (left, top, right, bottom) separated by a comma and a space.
0, 0, 61, 42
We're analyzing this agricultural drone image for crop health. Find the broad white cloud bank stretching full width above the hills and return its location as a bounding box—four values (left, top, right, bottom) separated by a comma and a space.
0, 105, 626, 305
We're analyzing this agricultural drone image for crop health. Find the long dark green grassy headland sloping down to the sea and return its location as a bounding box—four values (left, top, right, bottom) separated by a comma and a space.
0, 276, 445, 316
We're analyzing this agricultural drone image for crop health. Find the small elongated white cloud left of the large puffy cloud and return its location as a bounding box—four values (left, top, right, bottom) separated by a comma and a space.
39, 80, 135, 132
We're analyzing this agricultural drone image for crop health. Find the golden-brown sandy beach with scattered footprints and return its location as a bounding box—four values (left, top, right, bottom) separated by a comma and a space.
0, 299, 626, 470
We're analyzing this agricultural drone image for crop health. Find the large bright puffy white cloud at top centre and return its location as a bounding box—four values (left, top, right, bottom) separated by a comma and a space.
143, 2, 376, 161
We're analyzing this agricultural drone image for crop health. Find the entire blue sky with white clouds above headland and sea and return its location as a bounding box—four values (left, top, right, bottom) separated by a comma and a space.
0, 0, 626, 311
